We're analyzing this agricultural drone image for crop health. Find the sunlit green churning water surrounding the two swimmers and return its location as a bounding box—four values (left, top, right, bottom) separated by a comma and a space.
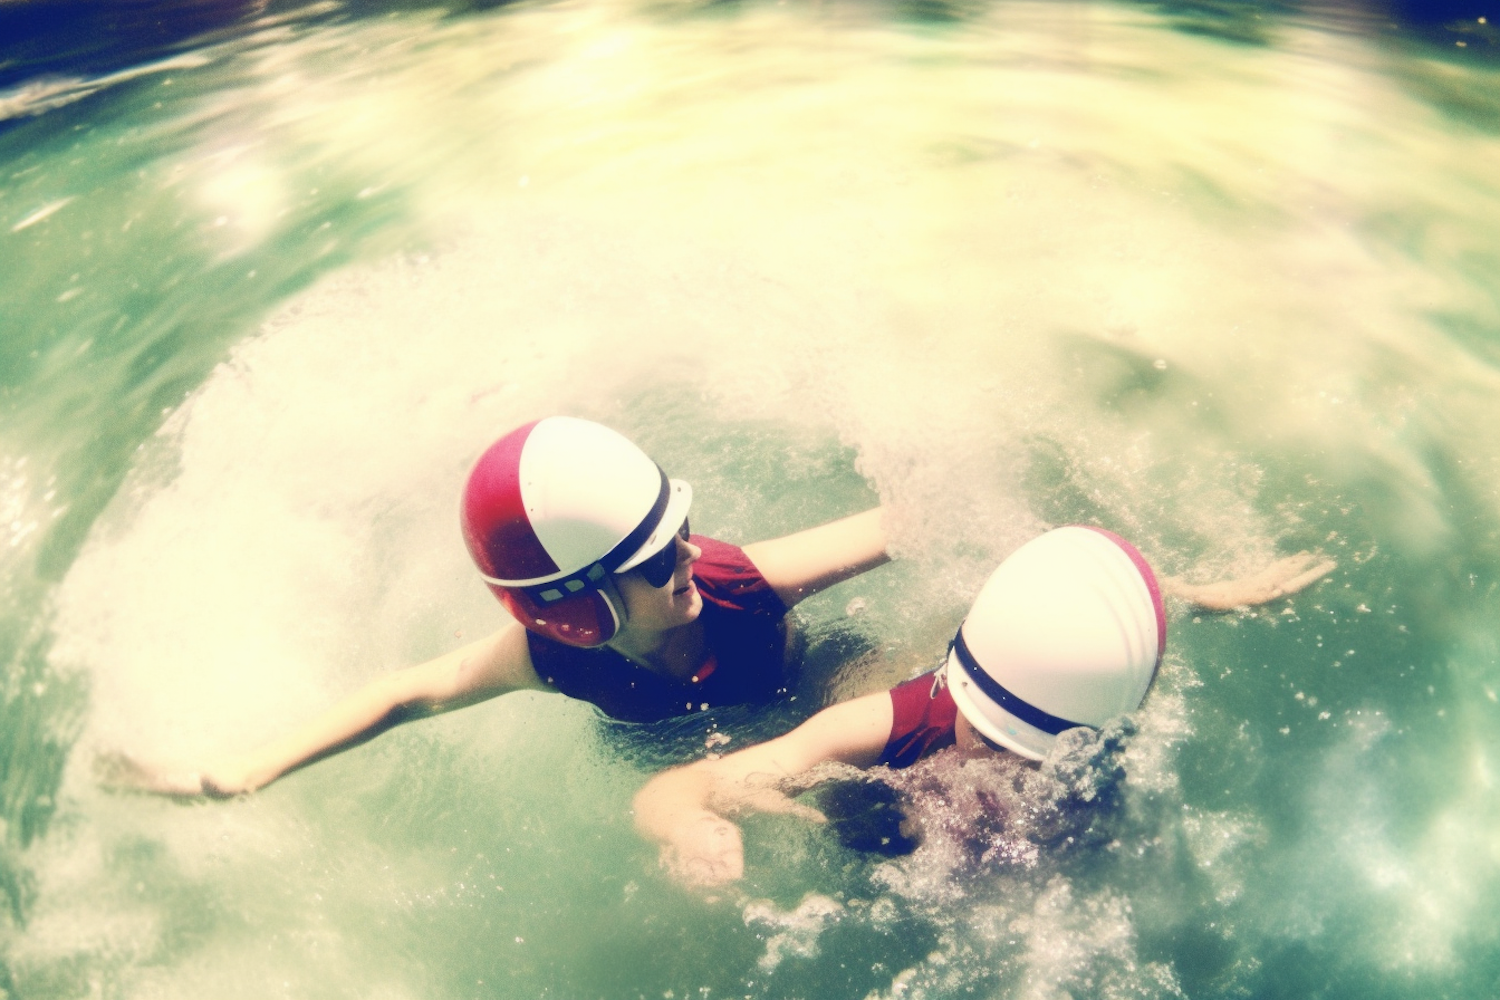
0, 0, 1500, 1000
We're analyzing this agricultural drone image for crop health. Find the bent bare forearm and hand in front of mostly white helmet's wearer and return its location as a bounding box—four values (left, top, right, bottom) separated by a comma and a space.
635, 691, 891, 886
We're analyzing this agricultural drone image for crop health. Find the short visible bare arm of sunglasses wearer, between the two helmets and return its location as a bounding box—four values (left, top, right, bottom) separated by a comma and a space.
746, 507, 890, 607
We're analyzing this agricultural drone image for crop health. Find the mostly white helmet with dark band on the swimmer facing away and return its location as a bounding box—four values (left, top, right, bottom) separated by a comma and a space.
945, 526, 1167, 760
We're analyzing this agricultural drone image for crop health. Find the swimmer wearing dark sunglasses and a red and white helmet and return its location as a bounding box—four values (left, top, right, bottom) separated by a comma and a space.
111, 417, 888, 798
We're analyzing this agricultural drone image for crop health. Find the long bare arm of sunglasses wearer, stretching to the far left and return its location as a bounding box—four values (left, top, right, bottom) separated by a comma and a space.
96, 625, 546, 798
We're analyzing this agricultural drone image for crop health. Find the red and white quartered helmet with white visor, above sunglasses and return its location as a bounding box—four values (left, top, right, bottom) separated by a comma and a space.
461, 417, 693, 646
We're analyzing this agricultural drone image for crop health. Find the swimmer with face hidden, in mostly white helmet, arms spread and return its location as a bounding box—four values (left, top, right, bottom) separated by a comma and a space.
635, 526, 1335, 888
